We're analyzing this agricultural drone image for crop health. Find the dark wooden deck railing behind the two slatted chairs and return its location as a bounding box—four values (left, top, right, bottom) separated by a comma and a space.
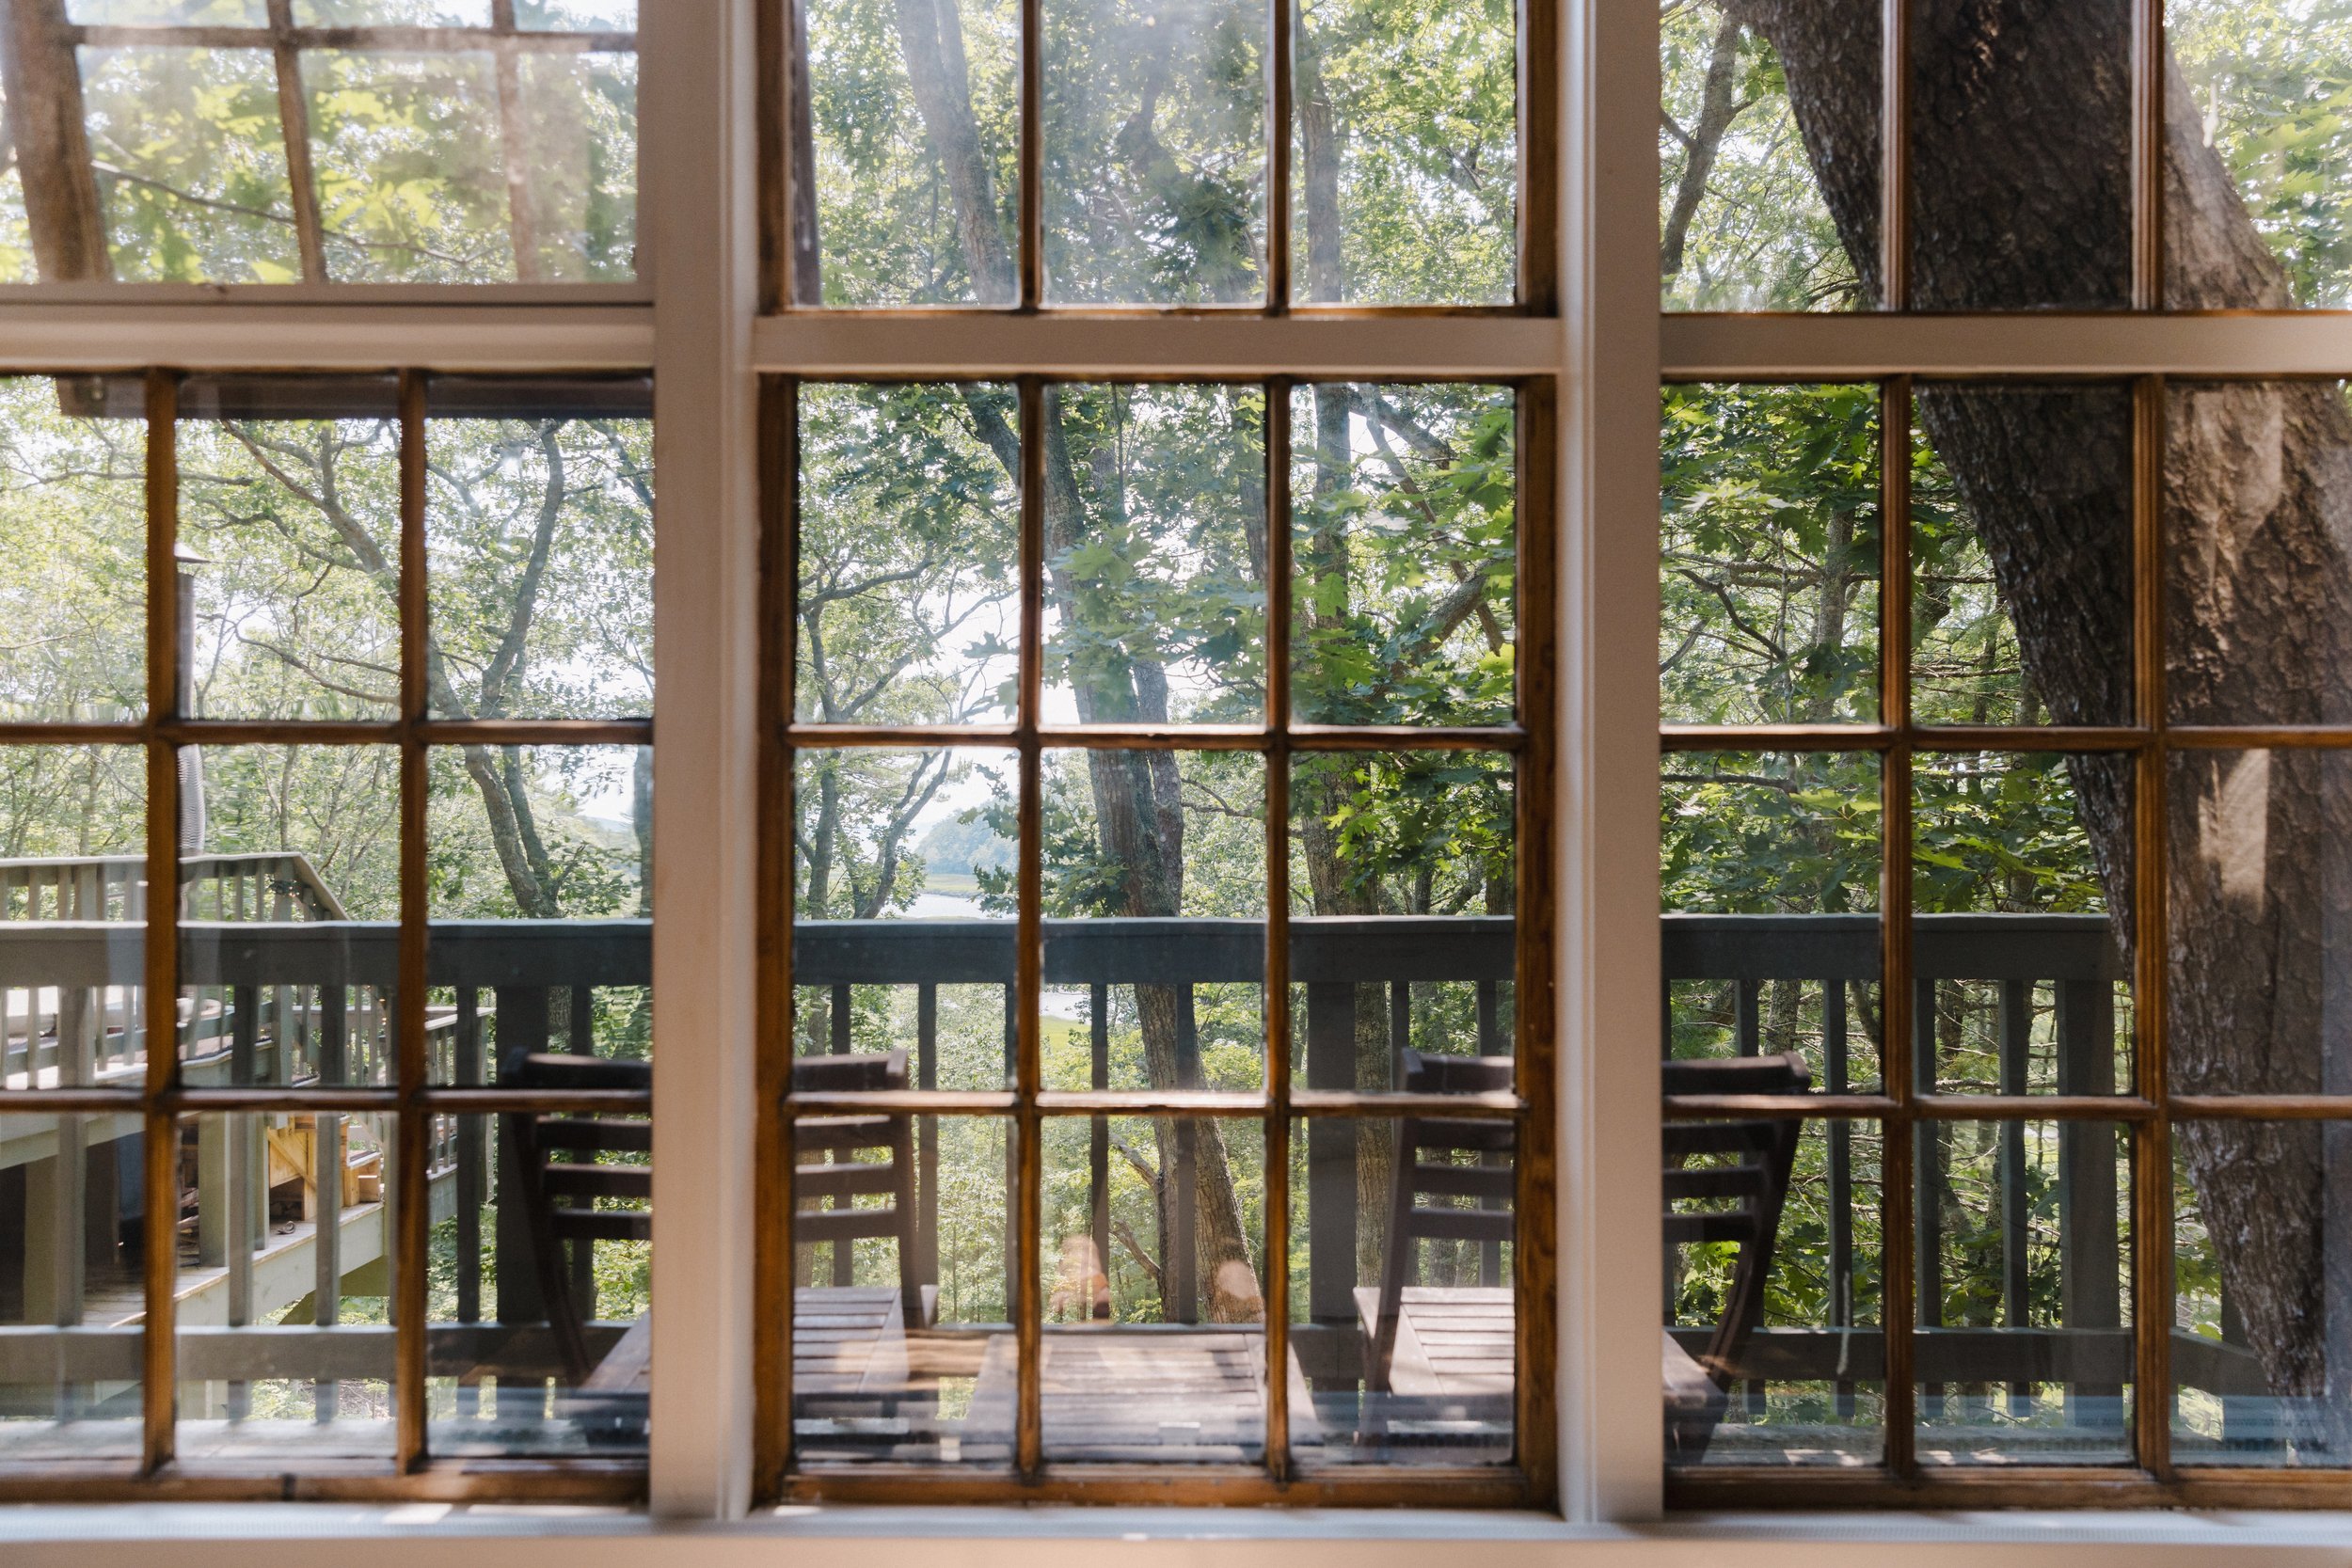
0, 907, 2265, 1438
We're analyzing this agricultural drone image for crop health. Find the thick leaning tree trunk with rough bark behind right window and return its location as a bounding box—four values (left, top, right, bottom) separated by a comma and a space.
1731, 0, 2352, 1453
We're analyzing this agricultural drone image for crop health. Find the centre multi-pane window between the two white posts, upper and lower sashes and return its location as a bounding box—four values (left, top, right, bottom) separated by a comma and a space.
757, 0, 1555, 1505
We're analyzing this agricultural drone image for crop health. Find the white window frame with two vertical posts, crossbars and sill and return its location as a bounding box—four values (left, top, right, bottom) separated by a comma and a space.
0, 0, 2352, 1542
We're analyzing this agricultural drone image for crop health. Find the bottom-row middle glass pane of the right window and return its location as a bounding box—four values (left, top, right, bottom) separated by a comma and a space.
1913, 1121, 2134, 1465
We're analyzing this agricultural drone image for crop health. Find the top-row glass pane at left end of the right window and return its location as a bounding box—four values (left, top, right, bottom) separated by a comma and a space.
1659, 0, 1884, 310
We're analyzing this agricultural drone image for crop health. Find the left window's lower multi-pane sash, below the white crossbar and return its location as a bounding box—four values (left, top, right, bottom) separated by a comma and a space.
0, 372, 652, 1496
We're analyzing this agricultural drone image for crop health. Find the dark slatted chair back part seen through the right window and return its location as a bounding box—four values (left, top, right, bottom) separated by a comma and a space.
1661, 1053, 1811, 1465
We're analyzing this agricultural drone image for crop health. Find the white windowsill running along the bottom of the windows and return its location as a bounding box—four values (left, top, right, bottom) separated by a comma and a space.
0, 1502, 2352, 1568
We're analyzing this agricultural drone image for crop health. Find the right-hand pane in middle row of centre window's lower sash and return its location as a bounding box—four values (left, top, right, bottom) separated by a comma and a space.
1292, 752, 1518, 1093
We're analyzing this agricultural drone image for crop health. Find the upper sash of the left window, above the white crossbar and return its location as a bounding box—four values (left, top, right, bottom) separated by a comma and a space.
0, 0, 638, 284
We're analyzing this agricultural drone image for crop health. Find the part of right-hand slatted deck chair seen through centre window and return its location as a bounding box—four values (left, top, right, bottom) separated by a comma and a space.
1364, 1051, 1518, 1394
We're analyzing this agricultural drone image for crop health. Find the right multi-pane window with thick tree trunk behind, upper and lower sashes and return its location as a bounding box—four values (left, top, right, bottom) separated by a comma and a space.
1659, 0, 2352, 1502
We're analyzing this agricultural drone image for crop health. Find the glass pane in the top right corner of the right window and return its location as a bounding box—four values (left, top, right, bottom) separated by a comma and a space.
2164, 0, 2352, 310
